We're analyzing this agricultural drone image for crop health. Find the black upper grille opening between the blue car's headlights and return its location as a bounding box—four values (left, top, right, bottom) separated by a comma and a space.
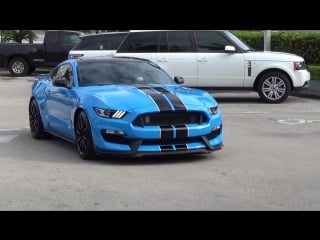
133, 111, 207, 127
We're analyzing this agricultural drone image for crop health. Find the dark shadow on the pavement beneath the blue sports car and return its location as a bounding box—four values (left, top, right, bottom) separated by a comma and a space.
13, 132, 216, 166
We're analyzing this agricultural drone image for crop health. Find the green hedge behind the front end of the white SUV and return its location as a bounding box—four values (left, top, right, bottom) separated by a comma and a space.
232, 30, 320, 64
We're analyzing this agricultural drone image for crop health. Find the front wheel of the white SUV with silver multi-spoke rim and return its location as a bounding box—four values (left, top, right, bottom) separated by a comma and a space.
257, 72, 291, 103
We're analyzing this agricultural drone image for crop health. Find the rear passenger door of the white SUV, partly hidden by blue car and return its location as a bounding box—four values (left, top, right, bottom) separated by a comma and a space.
156, 31, 197, 87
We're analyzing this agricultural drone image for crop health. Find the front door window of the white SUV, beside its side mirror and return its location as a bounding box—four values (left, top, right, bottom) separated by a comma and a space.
195, 31, 230, 52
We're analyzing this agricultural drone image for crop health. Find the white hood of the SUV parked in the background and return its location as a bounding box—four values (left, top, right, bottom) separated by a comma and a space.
245, 51, 304, 62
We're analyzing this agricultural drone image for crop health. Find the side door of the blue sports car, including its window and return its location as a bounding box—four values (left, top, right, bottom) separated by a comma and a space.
45, 64, 76, 139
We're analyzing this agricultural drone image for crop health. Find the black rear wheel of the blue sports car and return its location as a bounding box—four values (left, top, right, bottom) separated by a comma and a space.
29, 99, 51, 139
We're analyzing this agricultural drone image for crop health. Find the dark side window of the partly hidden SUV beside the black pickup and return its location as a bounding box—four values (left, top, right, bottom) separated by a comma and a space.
73, 33, 127, 50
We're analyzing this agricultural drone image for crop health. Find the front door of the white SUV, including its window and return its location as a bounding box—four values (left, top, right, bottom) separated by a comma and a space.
194, 31, 245, 88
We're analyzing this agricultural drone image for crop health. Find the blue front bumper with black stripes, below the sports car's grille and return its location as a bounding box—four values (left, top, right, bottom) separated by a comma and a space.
87, 110, 223, 156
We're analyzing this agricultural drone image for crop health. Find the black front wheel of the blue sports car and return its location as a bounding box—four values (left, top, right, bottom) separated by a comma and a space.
75, 111, 96, 160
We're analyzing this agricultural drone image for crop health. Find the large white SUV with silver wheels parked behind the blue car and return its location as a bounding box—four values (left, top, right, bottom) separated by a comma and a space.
115, 30, 310, 103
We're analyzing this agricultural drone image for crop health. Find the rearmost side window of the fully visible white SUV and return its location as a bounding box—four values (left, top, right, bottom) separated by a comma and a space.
118, 32, 160, 53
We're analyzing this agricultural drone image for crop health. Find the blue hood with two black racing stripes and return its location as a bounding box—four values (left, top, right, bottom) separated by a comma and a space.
82, 85, 217, 111
